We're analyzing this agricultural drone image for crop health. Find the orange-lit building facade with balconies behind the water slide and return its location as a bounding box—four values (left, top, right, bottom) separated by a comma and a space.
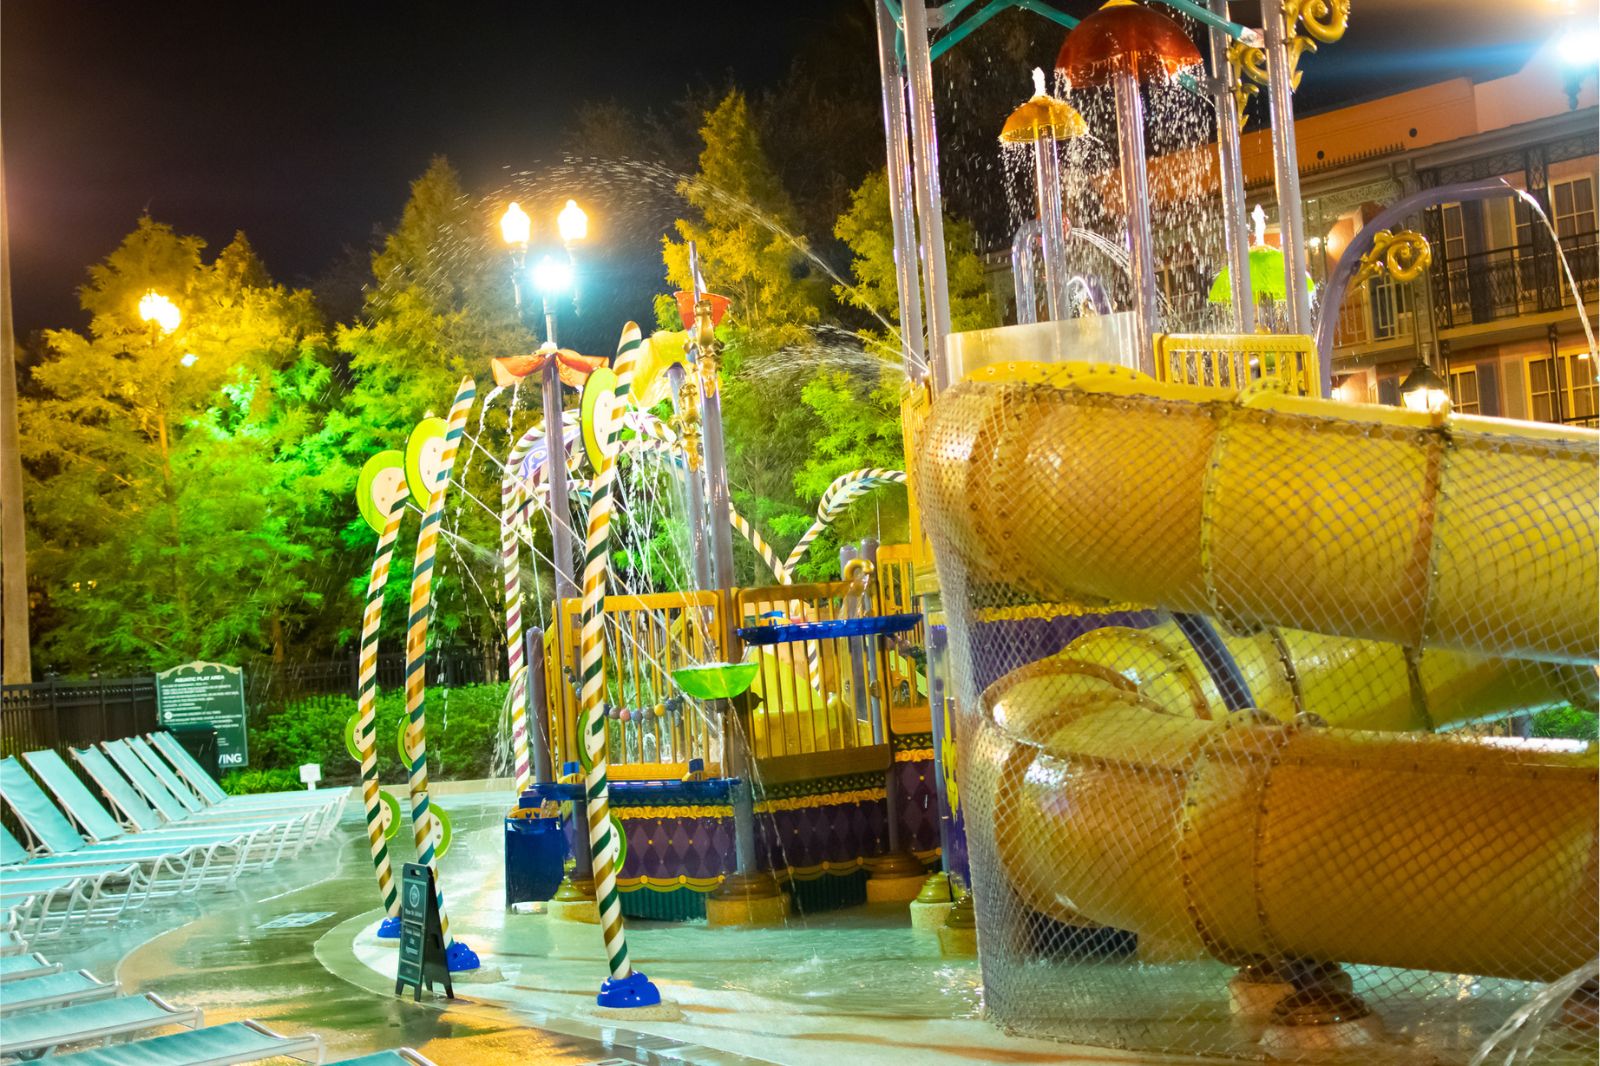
989, 46, 1600, 426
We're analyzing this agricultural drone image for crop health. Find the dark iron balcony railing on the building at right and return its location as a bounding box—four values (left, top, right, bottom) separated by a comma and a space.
1429, 232, 1600, 330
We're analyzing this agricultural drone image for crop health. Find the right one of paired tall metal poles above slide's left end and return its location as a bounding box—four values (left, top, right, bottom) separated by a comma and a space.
904, 0, 950, 392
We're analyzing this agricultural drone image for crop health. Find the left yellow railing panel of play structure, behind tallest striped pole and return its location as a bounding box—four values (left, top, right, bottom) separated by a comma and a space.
546, 592, 722, 779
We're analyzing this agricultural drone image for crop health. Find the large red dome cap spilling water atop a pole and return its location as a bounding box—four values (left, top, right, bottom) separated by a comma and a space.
1056, 0, 1200, 88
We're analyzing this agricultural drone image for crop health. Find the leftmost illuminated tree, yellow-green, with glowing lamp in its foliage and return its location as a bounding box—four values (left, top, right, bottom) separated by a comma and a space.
22, 218, 330, 669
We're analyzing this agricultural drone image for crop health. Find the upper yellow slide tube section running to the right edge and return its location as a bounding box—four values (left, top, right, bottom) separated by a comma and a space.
918, 363, 1600, 663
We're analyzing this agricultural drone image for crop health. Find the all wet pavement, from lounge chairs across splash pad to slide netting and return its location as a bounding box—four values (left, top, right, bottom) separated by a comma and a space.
42, 794, 1173, 1066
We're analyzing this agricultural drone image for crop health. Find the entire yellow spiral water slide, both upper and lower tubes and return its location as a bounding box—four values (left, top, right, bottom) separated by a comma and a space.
920, 365, 1600, 980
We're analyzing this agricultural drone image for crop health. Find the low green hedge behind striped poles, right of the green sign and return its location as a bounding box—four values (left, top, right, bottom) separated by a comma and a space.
222, 683, 507, 792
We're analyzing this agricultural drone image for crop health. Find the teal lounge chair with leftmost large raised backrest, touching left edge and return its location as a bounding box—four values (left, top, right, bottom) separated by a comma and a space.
0, 755, 250, 895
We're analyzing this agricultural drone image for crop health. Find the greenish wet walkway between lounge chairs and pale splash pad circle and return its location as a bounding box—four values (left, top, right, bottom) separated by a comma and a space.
40, 787, 749, 1066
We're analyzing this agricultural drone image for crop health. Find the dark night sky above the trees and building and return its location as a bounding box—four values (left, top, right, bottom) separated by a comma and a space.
0, 0, 1560, 336
